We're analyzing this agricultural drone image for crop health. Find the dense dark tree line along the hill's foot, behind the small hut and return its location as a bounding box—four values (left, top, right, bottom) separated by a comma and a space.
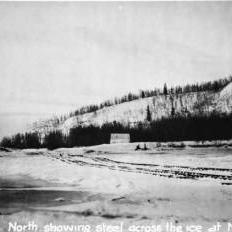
1, 112, 232, 149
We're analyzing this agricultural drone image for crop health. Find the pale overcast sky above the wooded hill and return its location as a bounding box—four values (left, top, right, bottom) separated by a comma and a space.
0, 2, 232, 136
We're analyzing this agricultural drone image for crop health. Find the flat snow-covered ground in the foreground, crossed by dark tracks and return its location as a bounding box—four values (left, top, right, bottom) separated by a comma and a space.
0, 143, 232, 232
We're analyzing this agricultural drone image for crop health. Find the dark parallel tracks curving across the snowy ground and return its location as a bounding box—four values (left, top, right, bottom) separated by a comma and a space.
53, 155, 232, 184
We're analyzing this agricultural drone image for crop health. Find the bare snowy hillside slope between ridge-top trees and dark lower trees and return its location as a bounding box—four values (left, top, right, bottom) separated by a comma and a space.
33, 83, 232, 133
